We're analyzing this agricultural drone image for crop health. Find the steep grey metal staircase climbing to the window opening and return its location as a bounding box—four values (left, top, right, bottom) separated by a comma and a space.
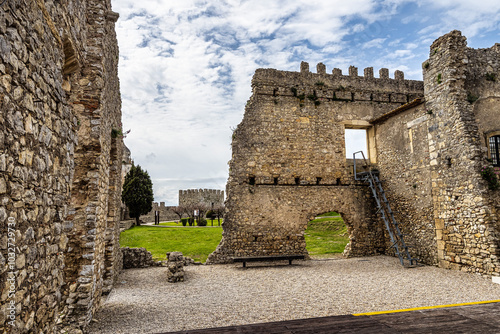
353, 151, 418, 267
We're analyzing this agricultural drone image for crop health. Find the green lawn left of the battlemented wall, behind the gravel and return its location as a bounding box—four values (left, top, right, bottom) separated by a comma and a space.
120, 225, 222, 262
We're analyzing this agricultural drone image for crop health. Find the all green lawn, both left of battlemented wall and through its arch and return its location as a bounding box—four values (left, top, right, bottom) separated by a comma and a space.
120, 212, 349, 262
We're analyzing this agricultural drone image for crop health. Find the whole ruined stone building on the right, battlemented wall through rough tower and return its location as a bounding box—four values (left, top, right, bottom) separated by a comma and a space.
209, 31, 500, 275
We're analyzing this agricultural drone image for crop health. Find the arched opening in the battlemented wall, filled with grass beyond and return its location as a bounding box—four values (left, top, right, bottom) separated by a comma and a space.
304, 211, 349, 259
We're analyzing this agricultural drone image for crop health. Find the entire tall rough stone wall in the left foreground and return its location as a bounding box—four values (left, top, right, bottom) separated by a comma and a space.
0, 0, 123, 333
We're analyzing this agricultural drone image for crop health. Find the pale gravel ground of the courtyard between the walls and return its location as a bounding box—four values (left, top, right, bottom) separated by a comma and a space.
89, 256, 500, 334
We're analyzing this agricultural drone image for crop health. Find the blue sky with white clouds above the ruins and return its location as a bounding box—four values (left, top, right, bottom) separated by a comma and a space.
112, 0, 500, 205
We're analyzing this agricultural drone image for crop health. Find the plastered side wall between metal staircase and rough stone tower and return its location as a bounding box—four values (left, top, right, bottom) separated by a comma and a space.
372, 101, 437, 265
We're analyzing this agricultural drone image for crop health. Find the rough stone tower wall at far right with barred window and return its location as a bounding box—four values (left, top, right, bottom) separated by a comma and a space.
423, 31, 500, 275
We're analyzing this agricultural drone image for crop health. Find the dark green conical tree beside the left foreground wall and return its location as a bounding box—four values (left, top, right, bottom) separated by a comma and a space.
122, 165, 154, 225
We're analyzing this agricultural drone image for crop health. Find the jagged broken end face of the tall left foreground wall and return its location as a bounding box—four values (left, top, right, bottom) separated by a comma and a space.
62, 0, 123, 327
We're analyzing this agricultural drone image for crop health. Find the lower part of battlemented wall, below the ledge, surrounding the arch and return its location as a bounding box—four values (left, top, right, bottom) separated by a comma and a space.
208, 183, 385, 263
